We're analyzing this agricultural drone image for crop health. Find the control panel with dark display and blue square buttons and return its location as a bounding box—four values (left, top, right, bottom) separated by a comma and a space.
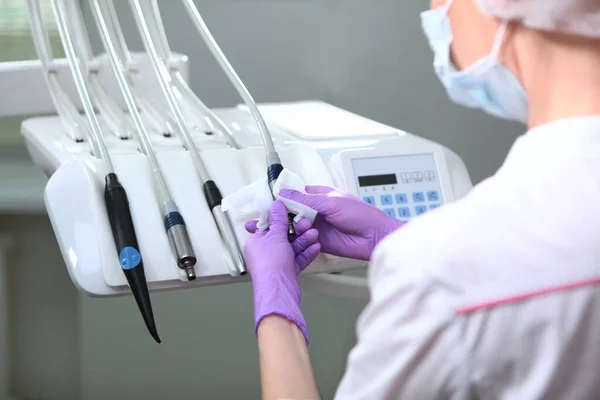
352, 154, 444, 222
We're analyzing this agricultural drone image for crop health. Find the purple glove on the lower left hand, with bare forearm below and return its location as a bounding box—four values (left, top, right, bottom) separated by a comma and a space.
244, 201, 321, 344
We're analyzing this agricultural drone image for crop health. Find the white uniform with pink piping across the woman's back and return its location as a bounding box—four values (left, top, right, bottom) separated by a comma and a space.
337, 116, 600, 400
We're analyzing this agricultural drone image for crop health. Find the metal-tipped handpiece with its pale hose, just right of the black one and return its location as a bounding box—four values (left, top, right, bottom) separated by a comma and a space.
90, 0, 197, 281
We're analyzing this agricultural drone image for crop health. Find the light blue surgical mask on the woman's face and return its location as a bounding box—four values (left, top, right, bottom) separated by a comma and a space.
421, 0, 529, 124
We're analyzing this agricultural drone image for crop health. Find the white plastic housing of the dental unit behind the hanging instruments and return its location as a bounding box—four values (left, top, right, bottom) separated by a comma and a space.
22, 102, 471, 298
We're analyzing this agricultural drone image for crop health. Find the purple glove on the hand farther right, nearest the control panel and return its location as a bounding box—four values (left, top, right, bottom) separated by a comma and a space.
280, 186, 404, 261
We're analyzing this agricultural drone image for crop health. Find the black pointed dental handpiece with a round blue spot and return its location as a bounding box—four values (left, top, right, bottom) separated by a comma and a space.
104, 173, 160, 343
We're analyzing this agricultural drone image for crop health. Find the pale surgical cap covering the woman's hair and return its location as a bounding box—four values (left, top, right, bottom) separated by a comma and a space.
475, 0, 600, 39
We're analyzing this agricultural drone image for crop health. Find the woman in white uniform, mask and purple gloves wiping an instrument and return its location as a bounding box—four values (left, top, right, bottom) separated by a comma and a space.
245, 0, 600, 400
